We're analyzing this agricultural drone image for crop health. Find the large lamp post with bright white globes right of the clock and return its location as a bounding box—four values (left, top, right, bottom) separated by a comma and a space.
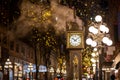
86, 15, 113, 80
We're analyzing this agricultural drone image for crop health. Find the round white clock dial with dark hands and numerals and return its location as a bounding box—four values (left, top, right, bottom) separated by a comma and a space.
70, 34, 81, 46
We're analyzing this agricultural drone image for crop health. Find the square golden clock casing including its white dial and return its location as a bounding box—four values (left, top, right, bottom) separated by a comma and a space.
67, 31, 84, 48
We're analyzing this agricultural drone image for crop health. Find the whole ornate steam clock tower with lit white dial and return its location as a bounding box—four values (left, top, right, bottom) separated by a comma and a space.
66, 22, 84, 80
